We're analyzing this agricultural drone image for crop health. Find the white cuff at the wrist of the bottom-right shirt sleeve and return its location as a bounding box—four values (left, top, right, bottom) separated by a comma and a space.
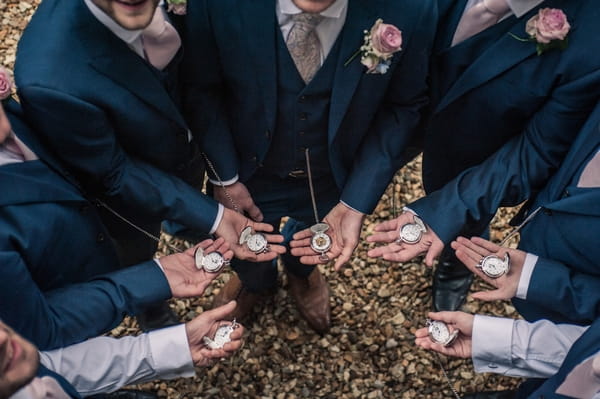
471, 315, 514, 374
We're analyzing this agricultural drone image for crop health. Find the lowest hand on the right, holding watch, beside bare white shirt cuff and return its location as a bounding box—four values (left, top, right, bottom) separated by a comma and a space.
415, 312, 475, 359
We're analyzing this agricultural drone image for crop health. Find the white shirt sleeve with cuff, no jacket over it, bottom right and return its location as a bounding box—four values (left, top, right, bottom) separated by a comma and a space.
471, 315, 589, 378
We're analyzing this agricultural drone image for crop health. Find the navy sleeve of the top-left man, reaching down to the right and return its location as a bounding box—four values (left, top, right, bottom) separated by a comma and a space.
19, 85, 217, 232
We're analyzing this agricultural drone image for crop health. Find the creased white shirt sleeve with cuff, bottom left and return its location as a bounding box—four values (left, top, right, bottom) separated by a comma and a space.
40, 324, 195, 396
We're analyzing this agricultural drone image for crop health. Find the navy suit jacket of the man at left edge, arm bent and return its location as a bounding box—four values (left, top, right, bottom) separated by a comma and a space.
0, 103, 171, 350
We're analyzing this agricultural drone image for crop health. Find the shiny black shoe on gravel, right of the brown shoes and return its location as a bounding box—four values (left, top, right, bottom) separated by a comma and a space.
433, 258, 473, 312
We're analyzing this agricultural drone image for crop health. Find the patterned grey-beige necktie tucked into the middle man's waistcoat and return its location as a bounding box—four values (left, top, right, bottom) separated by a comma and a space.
286, 12, 323, 84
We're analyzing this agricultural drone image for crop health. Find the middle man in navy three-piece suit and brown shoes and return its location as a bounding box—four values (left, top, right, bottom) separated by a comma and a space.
183, 0, 436, 332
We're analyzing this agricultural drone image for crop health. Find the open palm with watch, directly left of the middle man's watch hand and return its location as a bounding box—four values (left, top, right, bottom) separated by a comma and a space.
215, 208, 285, 262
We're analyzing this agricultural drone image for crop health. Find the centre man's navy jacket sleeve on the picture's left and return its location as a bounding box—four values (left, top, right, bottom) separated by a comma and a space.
180, 0, 239, 181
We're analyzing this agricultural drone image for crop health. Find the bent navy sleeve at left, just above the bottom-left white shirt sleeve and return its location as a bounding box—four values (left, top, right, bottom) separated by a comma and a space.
0, 248, 171, 350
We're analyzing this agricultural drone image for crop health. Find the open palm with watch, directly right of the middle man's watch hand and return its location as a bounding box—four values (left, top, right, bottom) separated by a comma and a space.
367, 212, 444, 266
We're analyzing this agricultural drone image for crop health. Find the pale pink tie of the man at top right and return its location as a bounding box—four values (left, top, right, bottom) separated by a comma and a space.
452, 0, 510, 46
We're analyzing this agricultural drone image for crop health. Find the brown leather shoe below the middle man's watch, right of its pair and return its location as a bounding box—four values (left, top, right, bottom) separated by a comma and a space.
287, 267, 331, 334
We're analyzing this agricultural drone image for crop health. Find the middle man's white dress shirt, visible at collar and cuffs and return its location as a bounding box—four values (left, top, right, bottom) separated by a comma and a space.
211, 0, 351, 188
